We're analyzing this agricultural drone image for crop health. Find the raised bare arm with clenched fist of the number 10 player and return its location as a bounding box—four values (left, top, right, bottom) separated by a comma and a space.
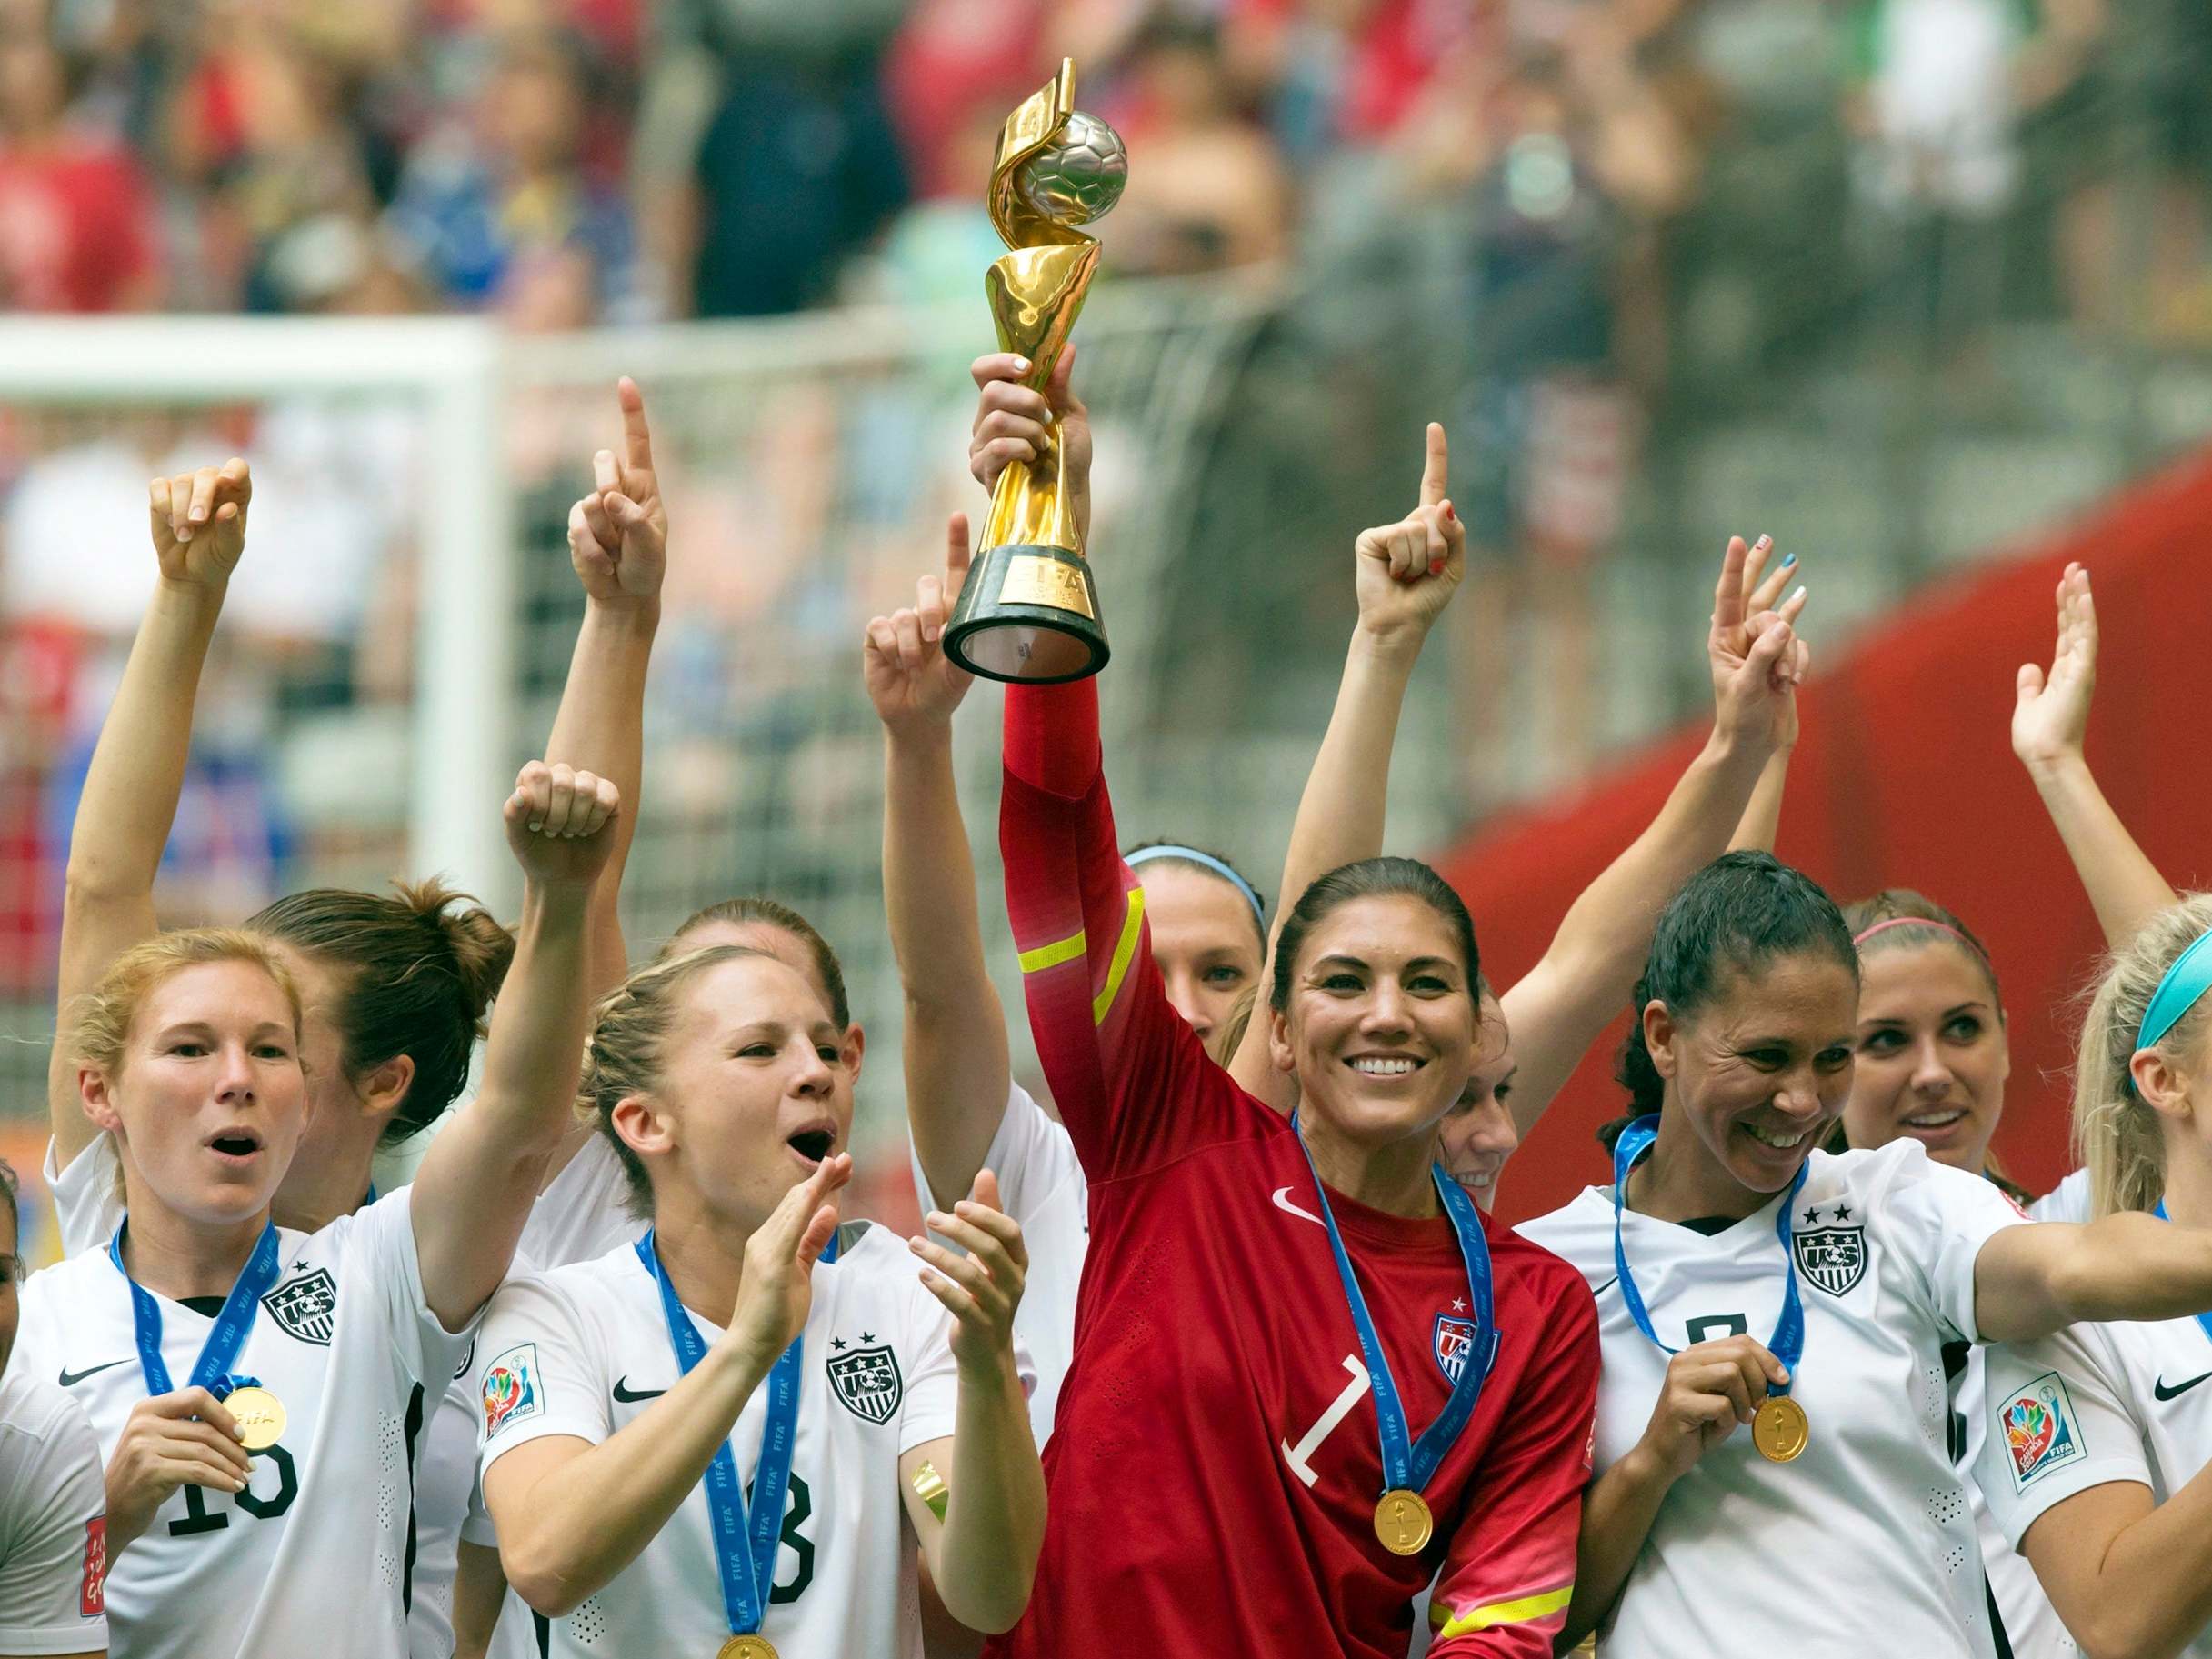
414, 761, 622, 1332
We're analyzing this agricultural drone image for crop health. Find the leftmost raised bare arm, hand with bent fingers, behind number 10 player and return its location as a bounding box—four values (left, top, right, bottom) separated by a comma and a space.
46, 455, 255, 1170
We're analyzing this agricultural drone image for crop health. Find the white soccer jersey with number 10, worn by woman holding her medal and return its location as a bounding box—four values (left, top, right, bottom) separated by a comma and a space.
15, 1190, 466, 1659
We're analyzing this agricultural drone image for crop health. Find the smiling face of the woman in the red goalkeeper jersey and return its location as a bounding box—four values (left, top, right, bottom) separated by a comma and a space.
1270, 894, 1506, 1148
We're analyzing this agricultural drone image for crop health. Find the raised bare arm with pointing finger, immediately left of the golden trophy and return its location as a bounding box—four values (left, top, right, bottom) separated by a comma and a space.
863, 514, 1011, 1221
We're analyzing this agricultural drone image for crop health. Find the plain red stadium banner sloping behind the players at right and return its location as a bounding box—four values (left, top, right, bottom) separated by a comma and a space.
1440, 454, 2212, 1221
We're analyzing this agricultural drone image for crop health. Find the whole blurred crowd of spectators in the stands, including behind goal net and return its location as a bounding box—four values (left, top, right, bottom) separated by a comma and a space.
0, 0, 2212, 1065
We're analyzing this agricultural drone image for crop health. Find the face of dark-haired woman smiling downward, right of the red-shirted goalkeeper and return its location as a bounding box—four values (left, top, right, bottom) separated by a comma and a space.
1644, 951, 1858, 1193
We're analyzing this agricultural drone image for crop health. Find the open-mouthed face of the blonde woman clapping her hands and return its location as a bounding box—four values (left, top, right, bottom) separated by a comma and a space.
615, 955, 852, 1232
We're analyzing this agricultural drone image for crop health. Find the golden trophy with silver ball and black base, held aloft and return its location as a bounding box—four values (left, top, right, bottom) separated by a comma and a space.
945, 60, 1128, 685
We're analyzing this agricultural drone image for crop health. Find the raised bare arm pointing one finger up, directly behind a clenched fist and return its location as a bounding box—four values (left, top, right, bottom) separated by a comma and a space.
546, 376, 668, 995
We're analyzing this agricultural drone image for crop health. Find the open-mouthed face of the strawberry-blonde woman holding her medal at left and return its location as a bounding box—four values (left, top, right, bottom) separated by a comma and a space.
77, 963, 310, 1224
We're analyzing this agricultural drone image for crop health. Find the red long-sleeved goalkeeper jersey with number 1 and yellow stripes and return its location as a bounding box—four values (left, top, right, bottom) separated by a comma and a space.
986, 681, 1597, 1659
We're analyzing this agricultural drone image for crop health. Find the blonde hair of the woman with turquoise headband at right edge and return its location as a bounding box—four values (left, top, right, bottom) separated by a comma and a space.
2073, 894, 2212, 1216
